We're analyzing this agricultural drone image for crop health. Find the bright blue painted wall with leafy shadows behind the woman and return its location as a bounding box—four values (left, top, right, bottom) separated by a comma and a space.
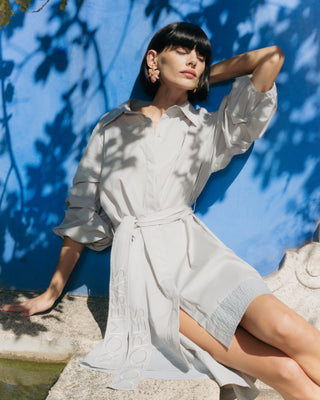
0, 0, 320, 296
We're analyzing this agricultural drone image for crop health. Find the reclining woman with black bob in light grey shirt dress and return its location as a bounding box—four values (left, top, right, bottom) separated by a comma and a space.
3, 22, 320, 400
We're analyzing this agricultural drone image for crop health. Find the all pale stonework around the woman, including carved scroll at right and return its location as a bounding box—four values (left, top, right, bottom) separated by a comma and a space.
0, 242, 320, 400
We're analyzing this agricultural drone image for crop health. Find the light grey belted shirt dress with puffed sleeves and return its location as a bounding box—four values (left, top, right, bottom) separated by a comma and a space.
54, 76, 277, 400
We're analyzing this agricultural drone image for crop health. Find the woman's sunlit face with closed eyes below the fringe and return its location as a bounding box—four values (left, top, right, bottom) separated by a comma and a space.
151, 47, 205, 91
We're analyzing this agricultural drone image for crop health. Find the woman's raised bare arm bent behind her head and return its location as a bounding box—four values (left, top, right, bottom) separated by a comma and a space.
210, 46, 284, 92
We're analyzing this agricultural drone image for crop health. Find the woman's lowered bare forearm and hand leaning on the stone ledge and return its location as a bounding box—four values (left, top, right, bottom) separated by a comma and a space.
1, 237, 84, 317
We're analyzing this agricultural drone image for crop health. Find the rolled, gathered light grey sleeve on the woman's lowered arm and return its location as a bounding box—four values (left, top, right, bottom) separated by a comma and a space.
53, 122, 113, 251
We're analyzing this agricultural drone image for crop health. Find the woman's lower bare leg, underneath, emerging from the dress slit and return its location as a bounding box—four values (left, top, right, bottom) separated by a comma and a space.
180, 309, 320, 400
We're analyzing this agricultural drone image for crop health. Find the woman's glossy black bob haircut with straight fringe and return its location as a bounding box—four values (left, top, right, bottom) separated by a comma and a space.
139, 22, 211, 101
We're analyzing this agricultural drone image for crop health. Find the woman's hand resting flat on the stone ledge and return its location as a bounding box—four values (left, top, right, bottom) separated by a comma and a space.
1, 290, 56, 317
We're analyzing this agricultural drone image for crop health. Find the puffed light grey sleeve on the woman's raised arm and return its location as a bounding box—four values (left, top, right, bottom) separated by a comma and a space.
211, 75, 277, 172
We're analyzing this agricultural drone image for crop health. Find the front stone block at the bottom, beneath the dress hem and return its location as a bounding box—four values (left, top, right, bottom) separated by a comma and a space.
46, 354, 282, 400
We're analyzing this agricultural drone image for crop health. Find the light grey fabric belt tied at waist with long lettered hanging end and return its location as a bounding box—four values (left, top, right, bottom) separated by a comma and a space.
102, 206, 193, 390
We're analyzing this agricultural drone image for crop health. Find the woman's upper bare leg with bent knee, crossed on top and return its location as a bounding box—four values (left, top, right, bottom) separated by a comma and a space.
241, 294, 320, 386
